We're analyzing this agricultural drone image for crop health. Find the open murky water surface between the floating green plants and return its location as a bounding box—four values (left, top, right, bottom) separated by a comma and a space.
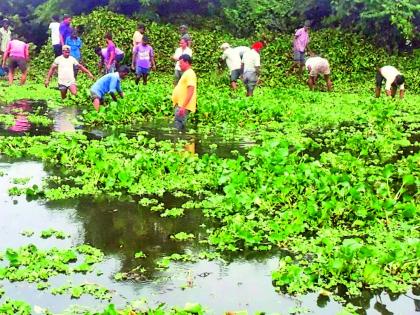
0, 100, 420, 315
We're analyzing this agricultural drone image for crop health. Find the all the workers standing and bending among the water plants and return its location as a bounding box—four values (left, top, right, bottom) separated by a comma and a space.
0, 15, 404, 129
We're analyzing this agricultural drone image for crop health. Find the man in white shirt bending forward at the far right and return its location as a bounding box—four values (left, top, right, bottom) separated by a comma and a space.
375, 66, 405, 99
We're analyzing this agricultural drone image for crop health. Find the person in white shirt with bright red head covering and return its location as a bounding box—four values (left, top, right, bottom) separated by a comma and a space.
242, 42, 264, 96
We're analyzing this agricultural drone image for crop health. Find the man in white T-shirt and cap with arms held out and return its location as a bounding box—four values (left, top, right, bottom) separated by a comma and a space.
45, 45, 94, 99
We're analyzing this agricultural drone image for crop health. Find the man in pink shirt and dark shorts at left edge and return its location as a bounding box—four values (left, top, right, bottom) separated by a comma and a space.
2, 36, 29, 85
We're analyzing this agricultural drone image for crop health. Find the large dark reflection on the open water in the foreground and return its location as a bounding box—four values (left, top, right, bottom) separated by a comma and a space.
47, 196, 209, 278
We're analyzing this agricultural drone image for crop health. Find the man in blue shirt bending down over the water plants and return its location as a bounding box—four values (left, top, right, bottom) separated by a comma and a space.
90, 66, 130, 111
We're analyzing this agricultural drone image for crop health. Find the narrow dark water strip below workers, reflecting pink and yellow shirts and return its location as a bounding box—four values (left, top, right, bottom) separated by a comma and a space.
3, 100, 256, 158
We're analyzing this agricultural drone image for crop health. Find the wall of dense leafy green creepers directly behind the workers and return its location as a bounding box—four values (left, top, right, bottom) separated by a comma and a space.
35, 10, 420, 92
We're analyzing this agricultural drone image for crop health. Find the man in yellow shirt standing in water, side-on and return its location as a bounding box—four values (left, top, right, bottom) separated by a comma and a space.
172, 54, 197, 130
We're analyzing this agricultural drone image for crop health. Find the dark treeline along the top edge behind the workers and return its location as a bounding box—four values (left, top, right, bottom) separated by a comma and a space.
0, 0, 420, 51
